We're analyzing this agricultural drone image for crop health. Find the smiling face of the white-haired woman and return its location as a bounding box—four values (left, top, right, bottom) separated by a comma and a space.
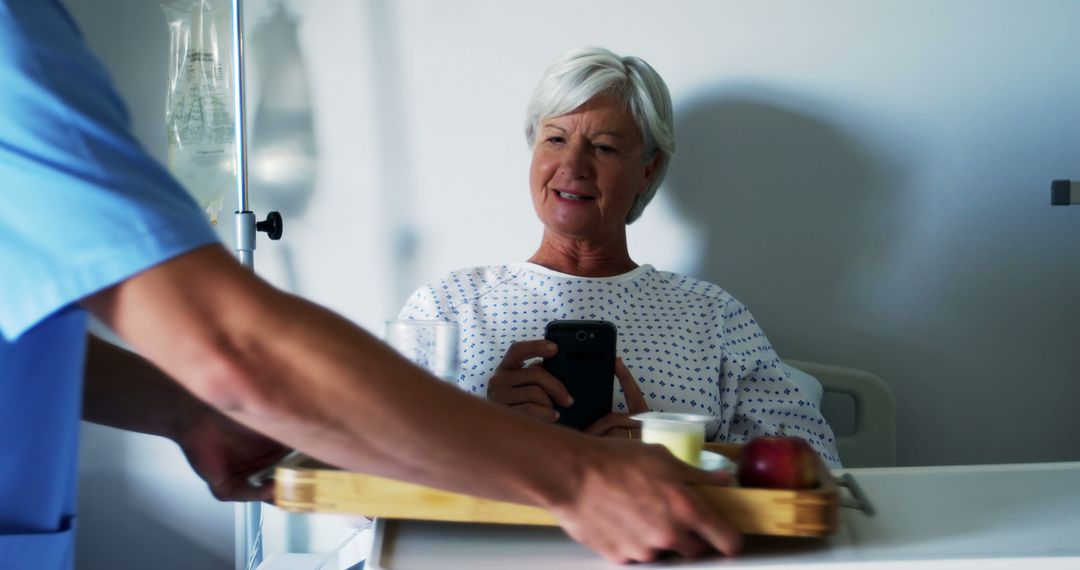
529, 95, 658, 240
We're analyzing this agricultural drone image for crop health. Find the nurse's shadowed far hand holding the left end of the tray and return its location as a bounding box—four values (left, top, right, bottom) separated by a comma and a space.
176, 409, 289, 501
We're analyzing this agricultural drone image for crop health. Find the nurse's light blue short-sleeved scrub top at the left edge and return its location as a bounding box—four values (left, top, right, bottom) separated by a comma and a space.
0, 0, 217, 569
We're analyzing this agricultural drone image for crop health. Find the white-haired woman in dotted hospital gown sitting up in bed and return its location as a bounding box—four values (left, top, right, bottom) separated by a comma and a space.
401, 49, 839, 465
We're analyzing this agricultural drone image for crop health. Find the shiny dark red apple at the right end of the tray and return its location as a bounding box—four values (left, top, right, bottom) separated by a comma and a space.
739, 436, 818, 489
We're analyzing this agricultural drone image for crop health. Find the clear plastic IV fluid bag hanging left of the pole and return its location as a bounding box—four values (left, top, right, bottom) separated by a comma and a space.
161, 0, 235, 223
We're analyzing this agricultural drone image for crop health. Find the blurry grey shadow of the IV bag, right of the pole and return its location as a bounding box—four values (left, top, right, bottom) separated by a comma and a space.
245, 2, 319, 293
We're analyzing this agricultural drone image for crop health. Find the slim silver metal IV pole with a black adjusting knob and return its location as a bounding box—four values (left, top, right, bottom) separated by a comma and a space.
232, 0, 282, 570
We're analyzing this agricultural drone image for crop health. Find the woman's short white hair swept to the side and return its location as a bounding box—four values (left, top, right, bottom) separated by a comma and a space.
525, 48, 675, 223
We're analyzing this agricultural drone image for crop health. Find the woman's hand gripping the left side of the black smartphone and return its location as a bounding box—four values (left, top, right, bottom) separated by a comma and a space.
487, 339, 573, 422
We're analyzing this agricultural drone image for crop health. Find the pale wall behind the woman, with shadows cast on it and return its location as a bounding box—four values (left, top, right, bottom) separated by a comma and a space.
68, 0, 1080, 556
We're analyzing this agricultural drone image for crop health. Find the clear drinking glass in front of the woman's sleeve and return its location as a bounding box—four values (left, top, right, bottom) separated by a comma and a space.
382, 320, 461, 382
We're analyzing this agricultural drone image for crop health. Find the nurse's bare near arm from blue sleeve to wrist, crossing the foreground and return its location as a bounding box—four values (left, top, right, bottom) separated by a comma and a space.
83, 245, 576, 500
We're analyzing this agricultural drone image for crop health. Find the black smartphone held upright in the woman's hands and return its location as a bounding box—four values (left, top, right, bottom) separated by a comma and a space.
543, 321, 617, 431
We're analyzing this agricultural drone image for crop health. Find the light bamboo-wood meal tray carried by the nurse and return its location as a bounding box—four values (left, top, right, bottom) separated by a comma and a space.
274, 444, 840, 537
